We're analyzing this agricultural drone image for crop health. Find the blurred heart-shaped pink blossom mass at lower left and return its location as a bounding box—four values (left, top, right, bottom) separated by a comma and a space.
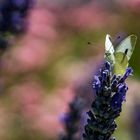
11, 80, 74, 138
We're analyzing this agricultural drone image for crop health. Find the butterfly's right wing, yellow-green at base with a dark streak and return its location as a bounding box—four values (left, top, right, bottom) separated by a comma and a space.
114, 35, 137, 75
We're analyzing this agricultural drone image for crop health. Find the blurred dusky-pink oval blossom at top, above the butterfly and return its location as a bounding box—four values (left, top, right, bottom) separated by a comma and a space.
60, 3, 112, 30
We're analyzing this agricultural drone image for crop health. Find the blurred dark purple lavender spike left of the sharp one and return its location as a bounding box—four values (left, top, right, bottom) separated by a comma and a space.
60, 96, 84, 140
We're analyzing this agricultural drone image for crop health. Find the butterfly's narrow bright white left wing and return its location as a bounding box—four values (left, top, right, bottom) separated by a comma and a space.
104, 34, 115, 64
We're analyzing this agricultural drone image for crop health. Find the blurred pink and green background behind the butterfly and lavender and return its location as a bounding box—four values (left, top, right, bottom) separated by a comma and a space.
0, 0, 140, 140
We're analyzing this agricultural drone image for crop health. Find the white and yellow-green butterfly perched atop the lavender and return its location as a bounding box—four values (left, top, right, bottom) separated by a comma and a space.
104, 34, 137, 75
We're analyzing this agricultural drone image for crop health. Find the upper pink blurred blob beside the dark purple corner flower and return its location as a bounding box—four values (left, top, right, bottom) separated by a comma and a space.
28, 8, 57, 41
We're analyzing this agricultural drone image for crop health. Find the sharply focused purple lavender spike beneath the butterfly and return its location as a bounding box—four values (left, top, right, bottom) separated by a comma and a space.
83, 61, 133, 140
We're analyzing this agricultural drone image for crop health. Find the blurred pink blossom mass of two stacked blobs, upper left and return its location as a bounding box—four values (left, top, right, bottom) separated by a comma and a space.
3, 8, 57, 74
